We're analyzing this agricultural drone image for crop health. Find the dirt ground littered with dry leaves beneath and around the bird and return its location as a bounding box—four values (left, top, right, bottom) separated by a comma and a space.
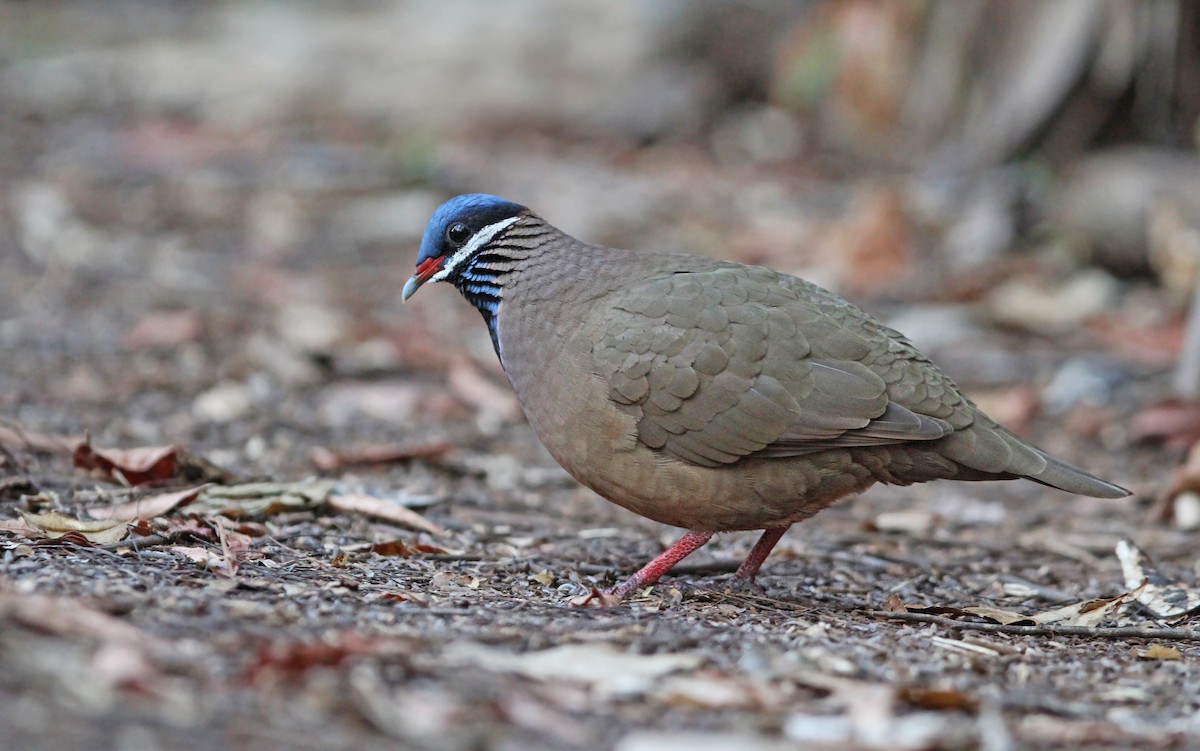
0, 6, 1200, 751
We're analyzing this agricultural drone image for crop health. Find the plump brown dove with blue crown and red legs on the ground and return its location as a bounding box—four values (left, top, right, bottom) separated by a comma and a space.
401, 193, 1129, 602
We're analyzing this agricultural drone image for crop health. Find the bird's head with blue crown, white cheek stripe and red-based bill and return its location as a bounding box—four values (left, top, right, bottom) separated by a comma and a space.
401, 193, 529, 301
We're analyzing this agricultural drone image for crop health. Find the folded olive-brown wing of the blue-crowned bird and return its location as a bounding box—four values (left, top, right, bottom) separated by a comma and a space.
593, 265, 961, 467
